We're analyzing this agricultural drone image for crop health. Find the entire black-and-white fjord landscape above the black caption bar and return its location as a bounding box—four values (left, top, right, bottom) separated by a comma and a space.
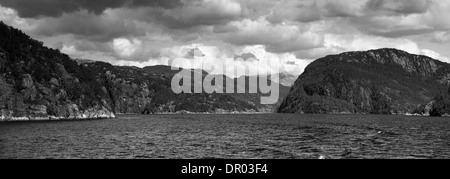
0, 0, 450, 159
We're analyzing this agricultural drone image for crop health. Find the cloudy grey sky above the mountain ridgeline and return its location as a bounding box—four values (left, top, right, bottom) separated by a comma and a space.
0, 0, 450, 76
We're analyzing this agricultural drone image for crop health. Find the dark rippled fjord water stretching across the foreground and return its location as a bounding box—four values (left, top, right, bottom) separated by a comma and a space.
0, 114, 450, 159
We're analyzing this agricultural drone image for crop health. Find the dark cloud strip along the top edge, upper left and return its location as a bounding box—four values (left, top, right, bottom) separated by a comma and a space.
0, 0, 182, 18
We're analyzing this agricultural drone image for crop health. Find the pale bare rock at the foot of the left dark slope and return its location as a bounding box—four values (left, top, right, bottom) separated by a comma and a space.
0, 75, 115, 121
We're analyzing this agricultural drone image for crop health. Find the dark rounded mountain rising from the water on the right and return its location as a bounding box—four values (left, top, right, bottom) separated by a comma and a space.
278, 49, 450, 114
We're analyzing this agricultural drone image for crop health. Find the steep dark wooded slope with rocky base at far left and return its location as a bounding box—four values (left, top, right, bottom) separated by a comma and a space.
0, 23, 115, 121
